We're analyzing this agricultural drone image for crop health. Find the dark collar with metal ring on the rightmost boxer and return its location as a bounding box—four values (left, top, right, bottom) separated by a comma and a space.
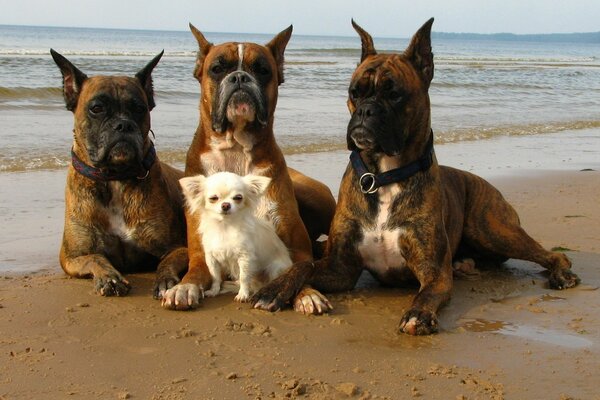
350, 131, 434, 194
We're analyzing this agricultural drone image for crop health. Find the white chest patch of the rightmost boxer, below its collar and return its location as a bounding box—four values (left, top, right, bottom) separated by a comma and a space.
358, 186, 406, 276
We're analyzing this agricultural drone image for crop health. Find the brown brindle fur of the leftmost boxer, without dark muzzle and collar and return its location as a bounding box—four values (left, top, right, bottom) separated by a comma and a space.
52, 52, 187, 296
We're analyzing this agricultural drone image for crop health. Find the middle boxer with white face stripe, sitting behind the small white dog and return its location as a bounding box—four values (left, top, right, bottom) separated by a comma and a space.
163, 24, 335, 313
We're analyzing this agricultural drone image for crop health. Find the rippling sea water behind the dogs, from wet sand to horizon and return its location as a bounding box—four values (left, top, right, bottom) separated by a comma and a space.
0, 26, 600, 173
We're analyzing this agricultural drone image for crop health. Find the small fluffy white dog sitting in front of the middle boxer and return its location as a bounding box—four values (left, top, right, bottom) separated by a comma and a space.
179, 172, 292, 302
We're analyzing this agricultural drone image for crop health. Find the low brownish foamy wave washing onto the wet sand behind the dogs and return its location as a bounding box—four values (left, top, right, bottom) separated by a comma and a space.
0, 120, 600, 172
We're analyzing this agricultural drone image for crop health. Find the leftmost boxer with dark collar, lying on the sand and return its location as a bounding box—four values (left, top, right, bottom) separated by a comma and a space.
50, 50, 187, 296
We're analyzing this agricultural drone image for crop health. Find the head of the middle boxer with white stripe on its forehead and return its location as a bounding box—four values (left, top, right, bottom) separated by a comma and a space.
190, 24, 292, 139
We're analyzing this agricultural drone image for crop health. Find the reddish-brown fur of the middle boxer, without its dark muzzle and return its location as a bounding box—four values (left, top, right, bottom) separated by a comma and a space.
163, 25, 335, 309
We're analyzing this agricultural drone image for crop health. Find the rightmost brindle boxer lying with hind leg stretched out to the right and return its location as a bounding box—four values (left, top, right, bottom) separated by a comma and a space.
252, 19, 579, 335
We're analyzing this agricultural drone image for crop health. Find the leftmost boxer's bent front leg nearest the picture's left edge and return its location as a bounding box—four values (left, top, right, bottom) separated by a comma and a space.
61, 254, 131, 296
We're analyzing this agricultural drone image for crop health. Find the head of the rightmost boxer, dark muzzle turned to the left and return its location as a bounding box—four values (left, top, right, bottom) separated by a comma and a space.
346, 18, 433, 156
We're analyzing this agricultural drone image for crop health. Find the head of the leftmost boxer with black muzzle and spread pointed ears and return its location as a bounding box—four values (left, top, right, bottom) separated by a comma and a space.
50, 49, 163, 172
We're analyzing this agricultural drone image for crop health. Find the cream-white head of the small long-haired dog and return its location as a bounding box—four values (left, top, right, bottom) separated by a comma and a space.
179, 172, 271, 220
